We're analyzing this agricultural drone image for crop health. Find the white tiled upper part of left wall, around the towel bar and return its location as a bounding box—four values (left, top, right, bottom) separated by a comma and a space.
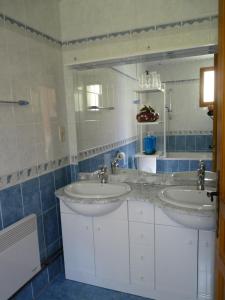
0, 0, 69, 175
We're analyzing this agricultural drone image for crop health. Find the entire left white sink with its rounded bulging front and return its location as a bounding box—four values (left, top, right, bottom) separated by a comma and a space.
63, 181, 131, 217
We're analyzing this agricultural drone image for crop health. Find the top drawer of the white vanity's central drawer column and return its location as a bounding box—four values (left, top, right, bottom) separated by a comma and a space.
128, 201, 154, 223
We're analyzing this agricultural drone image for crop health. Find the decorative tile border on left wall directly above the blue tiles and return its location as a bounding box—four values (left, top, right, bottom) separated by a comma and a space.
0, 156, 70, 190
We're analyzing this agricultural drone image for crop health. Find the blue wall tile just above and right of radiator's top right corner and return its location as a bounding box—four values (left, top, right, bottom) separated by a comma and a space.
40, 173, 56, 211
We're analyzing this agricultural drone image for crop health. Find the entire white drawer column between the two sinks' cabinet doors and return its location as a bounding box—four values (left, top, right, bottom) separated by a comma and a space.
128, 201, 154, 293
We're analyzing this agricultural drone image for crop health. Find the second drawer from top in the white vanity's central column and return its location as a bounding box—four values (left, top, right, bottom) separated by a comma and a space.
129, 222, 154, 246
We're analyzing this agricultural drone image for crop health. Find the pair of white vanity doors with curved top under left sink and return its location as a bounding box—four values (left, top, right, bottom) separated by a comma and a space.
60, 201, 130, 289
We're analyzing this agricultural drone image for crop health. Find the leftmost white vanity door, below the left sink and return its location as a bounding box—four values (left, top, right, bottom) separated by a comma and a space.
61, 213, 95, 280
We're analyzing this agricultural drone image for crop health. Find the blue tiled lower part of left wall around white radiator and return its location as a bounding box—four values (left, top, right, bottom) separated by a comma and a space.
0, 166, 71, 300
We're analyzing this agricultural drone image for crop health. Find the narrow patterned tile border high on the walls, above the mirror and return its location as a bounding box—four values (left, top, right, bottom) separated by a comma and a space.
0, 13, 218, 47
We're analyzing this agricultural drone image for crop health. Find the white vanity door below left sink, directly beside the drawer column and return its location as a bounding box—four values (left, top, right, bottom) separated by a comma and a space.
94, 217, 129, 283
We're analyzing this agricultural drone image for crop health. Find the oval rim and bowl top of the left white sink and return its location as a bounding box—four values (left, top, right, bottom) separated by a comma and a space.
64, 181, 131, 199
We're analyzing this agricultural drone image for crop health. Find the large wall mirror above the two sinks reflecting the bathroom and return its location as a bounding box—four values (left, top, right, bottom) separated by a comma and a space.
73, 55, 213, 172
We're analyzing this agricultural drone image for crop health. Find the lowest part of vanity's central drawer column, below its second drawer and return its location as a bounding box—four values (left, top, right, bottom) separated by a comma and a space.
130, 245, 154, 288
